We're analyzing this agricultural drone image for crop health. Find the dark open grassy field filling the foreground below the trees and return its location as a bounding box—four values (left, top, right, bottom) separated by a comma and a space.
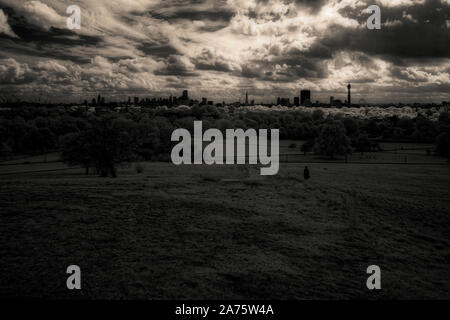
0, 156, 450, 299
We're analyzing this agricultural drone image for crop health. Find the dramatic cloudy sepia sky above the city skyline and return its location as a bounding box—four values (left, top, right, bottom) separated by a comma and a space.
0, 0, 450, 102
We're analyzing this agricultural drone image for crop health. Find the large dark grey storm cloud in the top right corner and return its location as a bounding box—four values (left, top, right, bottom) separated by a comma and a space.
324, 0, 450, 62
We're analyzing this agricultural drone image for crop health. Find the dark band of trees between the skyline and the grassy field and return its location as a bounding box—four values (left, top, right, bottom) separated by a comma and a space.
0, 106, 450, 177
